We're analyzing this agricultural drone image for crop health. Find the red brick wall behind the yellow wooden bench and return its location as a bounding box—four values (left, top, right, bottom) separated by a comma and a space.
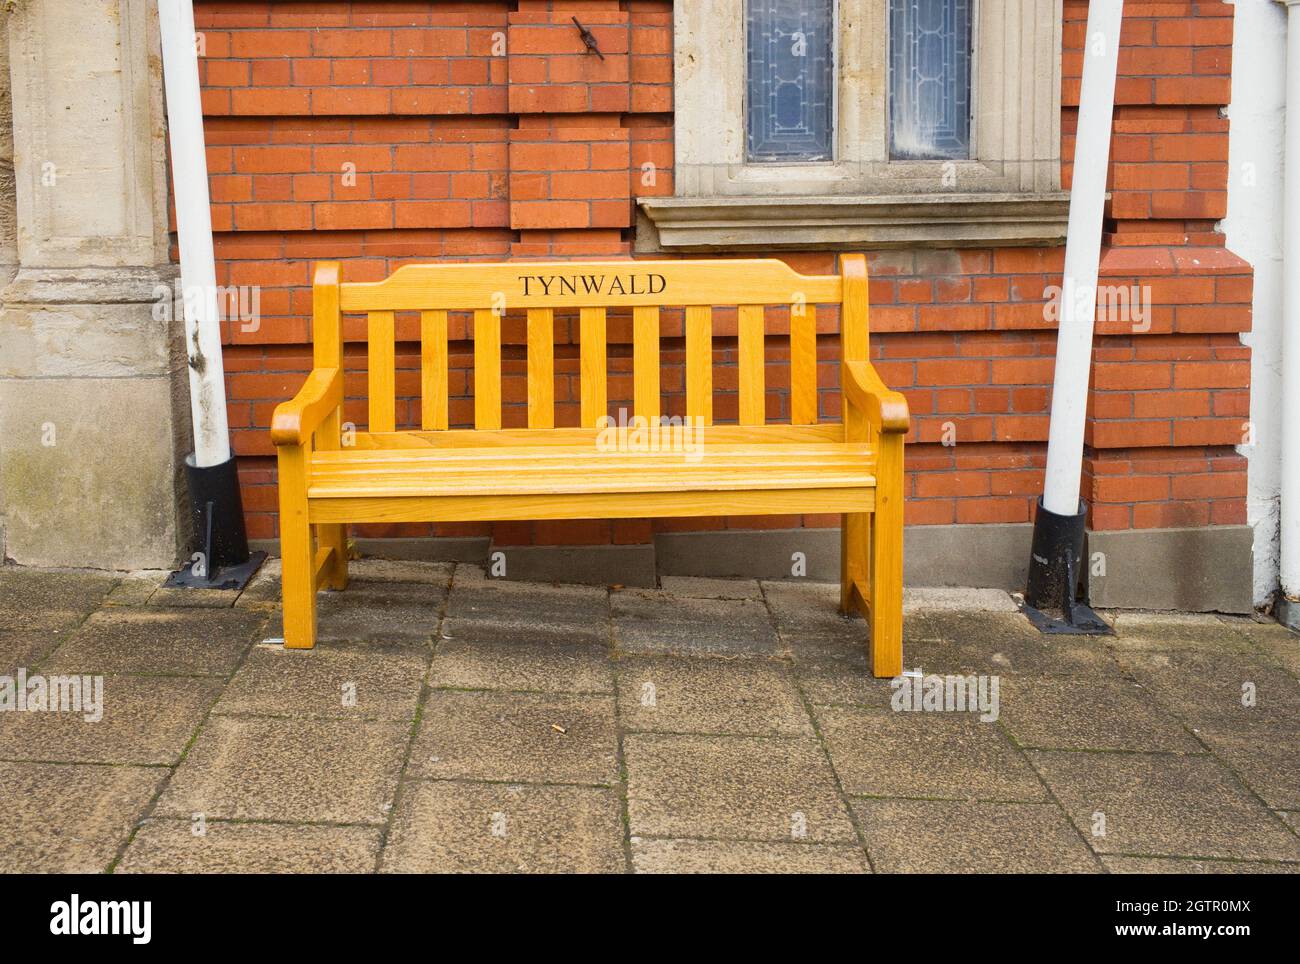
189, 0, 1252, 544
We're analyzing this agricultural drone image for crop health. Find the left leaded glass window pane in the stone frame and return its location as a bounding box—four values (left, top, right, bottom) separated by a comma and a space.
745, 0, 835, 161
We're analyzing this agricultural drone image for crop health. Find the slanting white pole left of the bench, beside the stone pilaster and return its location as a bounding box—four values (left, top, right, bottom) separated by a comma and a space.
159, 0, 230, 468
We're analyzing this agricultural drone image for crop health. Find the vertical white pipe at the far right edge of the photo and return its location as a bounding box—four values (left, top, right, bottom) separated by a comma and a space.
1278, 0, 1300, 602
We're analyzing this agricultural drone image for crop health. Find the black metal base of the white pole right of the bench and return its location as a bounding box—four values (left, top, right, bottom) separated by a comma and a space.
1019, 496, 1114, 635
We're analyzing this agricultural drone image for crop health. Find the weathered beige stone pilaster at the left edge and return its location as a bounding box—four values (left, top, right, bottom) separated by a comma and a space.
0, 0, 189, 569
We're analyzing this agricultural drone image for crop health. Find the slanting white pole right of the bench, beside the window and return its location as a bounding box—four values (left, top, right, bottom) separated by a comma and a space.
1043, 0, 1125, 516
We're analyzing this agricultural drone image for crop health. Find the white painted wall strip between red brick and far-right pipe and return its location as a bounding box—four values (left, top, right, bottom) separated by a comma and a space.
1222, 0, 1284, 604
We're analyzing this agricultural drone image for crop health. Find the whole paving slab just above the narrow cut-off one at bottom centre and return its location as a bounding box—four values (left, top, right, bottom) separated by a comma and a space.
624, 733, 857, 843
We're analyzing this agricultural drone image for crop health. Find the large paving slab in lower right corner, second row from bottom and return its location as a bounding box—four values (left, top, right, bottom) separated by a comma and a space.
1028, 750, 1300, 860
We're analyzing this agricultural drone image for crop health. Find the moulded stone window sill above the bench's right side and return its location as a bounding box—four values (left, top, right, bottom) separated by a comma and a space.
636, 191, 1070, 252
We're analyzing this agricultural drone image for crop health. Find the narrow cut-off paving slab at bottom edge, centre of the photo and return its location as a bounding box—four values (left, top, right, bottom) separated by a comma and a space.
632, 837, 871, 873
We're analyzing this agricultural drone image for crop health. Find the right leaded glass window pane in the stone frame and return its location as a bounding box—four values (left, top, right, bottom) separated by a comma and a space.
889, 0, 975, 159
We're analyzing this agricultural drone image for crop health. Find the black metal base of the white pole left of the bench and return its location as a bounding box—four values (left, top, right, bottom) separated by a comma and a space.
164, 455, 267, 590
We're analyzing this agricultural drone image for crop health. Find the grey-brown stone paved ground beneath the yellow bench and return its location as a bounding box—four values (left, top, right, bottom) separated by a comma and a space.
0, 560, 1300, 873
